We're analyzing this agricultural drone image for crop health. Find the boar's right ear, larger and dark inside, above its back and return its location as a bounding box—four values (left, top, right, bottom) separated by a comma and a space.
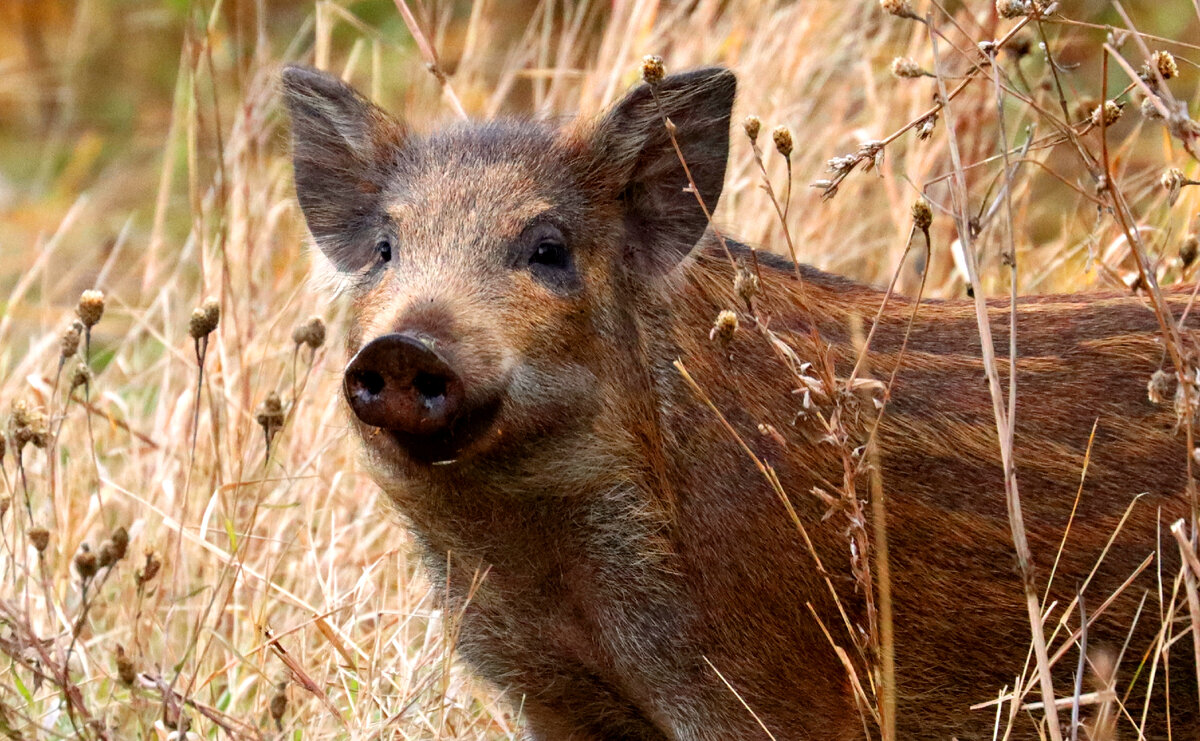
589, 67, 737, 275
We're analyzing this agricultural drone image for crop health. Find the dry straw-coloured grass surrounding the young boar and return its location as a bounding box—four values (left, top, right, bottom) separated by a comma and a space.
0, 0, 1200, 739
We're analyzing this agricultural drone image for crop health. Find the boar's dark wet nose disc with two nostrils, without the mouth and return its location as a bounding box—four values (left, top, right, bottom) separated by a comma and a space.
344, 333, 464, 438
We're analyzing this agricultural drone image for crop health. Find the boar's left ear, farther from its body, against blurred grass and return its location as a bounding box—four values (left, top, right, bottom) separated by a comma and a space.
282, 66, 404, 271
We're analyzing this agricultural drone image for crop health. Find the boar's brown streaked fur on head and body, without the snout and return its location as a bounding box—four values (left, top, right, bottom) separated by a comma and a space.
286, 70, 1198, 741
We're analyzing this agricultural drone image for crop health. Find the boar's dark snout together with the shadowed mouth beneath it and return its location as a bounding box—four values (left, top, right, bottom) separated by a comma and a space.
343, 332, 497, 462
